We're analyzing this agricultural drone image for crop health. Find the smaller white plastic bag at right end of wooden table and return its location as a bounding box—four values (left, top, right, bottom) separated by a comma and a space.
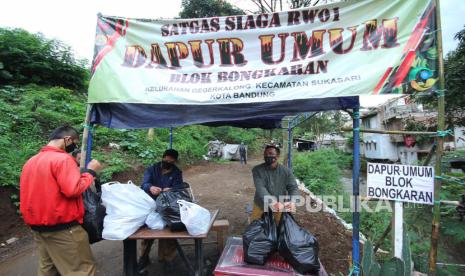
178, 200, 211, 236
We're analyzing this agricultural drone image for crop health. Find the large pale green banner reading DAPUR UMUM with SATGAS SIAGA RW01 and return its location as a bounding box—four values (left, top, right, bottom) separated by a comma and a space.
89, 0, 438, 105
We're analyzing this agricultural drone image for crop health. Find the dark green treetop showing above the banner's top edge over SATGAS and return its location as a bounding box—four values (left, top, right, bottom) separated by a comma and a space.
179, 0, 245, 18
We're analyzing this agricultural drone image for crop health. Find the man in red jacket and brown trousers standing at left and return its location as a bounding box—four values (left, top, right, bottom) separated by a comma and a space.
20, 126, 101, 276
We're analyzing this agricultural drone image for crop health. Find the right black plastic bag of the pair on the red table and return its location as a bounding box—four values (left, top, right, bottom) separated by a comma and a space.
278, 213, 320, 274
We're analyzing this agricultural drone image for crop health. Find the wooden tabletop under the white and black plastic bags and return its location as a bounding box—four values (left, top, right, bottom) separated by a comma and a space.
127, 209, 220, 240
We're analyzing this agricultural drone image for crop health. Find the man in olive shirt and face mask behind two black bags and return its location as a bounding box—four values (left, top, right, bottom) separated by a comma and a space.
251, 145, 300, 222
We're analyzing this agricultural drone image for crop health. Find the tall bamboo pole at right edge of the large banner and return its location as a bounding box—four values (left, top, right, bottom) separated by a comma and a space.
429, 0, 445, 276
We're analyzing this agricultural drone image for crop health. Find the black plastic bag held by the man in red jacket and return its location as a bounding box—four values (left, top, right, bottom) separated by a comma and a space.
82, 188, 106, 243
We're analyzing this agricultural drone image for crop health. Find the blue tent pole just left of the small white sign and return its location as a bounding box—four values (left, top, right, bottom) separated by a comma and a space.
352, 107, 360, 276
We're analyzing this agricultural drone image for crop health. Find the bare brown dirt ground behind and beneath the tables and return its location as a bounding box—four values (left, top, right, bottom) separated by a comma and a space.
0, 160, 351, 275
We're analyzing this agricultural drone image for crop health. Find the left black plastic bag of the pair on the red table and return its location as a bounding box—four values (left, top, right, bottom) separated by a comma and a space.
242, 211, 278, 265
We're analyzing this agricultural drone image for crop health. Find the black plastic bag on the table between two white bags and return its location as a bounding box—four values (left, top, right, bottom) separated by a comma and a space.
156, 189, 192, 232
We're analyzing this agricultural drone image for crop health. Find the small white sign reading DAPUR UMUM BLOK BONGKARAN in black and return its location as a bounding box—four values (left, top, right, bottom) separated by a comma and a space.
367, 163, 434, 205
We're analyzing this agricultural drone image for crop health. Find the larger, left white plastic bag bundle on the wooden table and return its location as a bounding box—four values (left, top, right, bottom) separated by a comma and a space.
102, 181, 156, 240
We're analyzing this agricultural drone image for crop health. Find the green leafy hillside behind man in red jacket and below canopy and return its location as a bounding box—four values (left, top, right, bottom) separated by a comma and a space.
0, 85, 259, 191
